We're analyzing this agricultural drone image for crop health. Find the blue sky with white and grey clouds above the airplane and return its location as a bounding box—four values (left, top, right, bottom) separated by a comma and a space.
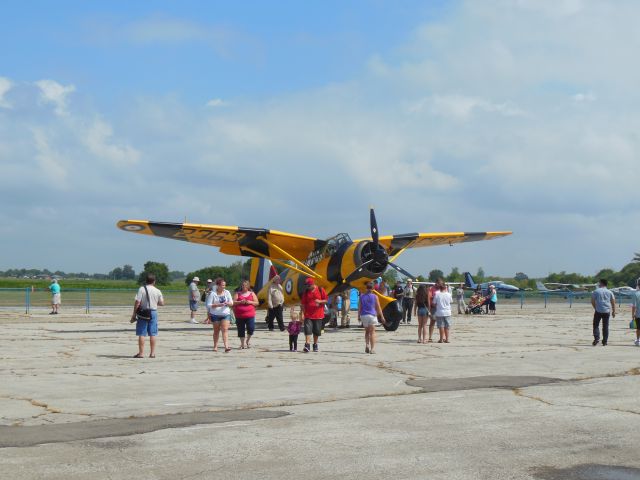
0, 0, 640, 277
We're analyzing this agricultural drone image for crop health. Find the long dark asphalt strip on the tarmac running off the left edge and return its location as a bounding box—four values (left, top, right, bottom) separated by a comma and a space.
0, 410, 289, 448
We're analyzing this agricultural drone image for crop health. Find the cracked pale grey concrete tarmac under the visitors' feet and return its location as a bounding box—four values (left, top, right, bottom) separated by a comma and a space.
0, 304, 640, 480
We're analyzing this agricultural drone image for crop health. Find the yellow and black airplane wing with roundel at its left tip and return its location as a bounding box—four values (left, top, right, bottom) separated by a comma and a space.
118, 220, 326, 262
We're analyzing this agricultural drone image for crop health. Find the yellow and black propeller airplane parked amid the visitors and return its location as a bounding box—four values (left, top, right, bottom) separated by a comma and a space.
118, 209, 511, 331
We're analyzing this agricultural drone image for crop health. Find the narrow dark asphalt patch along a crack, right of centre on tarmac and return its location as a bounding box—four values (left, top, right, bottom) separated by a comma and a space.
407, 375, 562, 393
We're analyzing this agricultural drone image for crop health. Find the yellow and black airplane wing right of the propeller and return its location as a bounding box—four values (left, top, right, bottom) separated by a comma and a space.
356, 232, 512, 256
